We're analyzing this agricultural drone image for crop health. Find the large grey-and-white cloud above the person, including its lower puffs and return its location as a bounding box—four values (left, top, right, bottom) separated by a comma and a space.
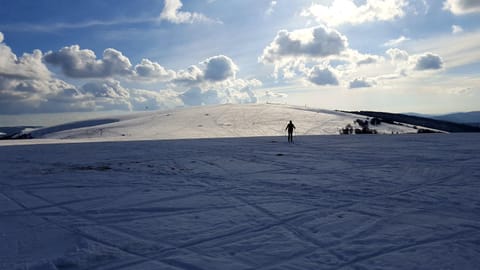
259, 26, 385, 86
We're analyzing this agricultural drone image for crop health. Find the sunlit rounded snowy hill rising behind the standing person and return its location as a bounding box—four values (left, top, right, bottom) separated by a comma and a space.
28, 104, 416, 140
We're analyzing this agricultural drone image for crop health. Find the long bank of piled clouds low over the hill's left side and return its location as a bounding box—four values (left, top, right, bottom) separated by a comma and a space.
0, 33, 262, 114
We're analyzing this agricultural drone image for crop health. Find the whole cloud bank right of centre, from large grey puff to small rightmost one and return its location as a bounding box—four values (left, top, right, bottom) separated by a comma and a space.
259, 22, 445, 89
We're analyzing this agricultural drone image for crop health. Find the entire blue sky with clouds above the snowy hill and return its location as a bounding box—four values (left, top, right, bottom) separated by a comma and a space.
0, 0, 480, 119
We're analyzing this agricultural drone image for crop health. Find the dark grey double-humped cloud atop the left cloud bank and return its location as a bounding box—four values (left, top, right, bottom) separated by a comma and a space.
44, 45, 132, 78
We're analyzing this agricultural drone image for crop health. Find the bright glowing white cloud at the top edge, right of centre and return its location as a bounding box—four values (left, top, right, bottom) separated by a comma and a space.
302, 0, 408, 26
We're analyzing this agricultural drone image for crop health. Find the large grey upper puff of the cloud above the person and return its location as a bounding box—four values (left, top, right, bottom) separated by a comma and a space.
260, 26, 348, 63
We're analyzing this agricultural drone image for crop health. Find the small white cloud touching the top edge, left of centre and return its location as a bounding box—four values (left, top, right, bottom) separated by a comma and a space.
160, 0, 215, 24
